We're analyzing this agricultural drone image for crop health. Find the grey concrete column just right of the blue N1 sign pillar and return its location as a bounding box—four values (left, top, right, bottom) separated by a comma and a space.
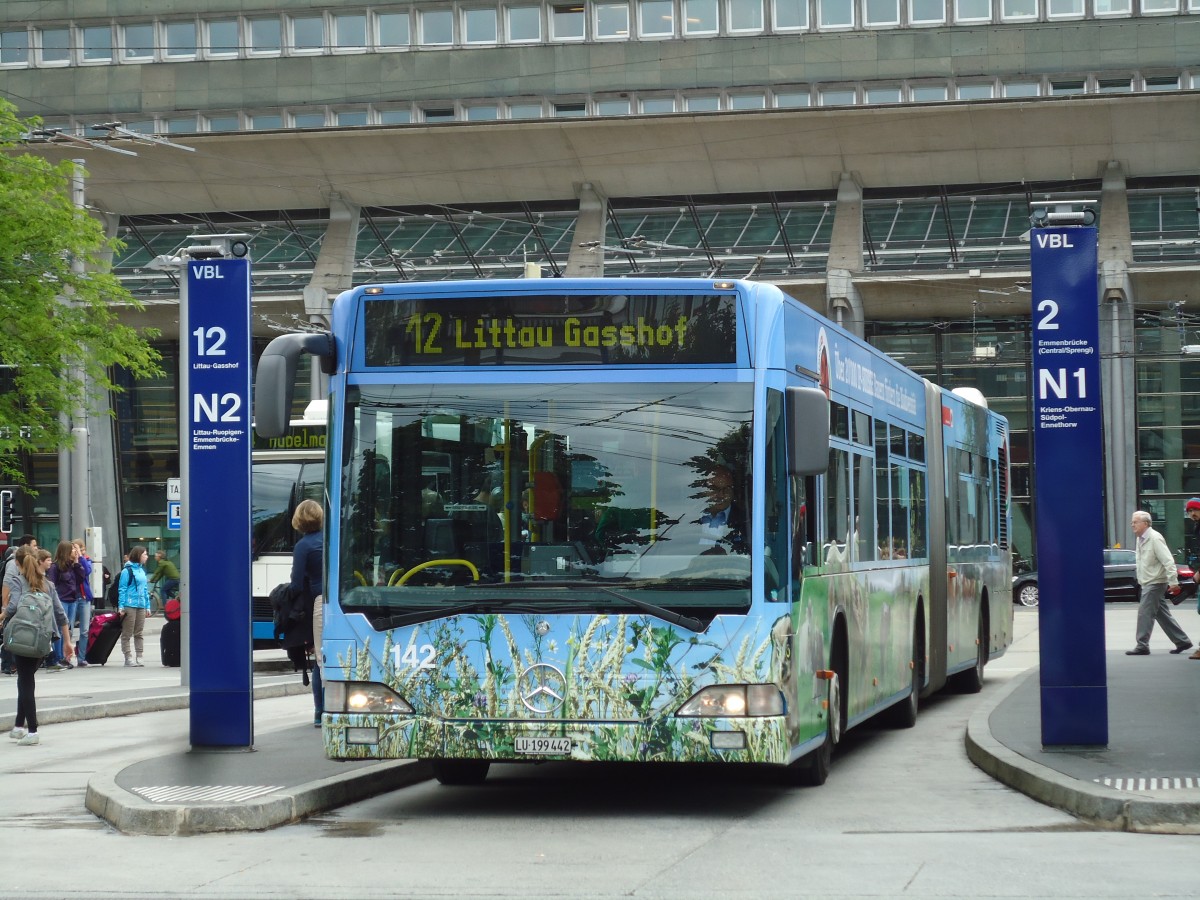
1098, 161, 1138, 546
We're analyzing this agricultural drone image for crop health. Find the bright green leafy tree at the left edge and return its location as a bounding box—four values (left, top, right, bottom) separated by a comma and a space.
0, 100, 161, 484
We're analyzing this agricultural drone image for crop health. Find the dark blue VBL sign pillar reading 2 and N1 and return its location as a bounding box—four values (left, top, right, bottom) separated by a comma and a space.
1030, 227, 1109, 748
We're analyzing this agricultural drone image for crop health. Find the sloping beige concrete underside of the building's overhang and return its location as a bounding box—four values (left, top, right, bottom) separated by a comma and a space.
21, 91, 1200, 215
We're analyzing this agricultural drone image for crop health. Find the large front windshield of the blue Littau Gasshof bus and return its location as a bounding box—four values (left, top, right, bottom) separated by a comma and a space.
338, 382, 752, 622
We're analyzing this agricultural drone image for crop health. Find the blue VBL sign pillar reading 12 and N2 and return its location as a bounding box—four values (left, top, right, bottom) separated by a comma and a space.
180, 259, 254, 748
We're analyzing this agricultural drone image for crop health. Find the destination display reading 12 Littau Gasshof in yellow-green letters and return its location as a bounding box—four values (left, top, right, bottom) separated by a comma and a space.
364, 294, 737, 367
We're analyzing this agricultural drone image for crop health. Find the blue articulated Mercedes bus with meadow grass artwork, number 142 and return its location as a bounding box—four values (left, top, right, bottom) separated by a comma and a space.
256, 278, 1013, 784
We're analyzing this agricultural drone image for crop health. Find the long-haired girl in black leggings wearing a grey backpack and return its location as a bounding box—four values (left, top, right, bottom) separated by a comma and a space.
4, 550, 74, 746
